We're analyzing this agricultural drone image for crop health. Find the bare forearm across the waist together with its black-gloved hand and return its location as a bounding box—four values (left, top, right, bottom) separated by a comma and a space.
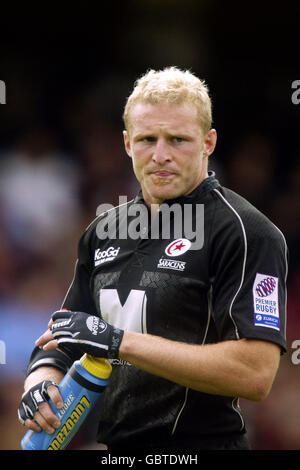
36, 311, 280, 401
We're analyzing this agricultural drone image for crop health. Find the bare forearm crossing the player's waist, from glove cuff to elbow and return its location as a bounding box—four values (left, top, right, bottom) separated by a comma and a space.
120, 332, 279, 400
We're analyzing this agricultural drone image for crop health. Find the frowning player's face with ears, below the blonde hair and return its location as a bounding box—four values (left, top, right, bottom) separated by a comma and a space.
124, 103, 216, 205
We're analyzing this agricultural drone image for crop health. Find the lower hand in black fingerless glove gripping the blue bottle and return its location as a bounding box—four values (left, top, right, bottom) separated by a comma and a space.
18, 380, 63, 434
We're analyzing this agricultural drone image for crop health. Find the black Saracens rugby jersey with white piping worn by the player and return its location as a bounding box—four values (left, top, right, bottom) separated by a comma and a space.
29, 172, 287, 448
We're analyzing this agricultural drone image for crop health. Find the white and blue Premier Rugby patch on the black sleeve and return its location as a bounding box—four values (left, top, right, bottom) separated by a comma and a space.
252, 273, 280, 330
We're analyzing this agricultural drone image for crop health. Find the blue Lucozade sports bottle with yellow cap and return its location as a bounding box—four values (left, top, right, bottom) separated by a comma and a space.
21, 354, 112, 450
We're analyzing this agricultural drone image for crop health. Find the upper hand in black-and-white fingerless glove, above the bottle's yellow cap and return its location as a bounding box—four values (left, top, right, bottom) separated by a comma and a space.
36, 310, 124, 359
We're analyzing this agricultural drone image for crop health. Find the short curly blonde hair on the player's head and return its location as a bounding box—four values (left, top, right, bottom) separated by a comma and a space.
123, 67, 212, 135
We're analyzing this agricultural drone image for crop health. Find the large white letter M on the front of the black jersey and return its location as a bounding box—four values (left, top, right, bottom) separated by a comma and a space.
100, 289, 147, 333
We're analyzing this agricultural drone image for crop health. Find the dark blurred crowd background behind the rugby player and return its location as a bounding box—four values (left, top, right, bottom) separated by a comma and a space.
0, 0, 300, 450
